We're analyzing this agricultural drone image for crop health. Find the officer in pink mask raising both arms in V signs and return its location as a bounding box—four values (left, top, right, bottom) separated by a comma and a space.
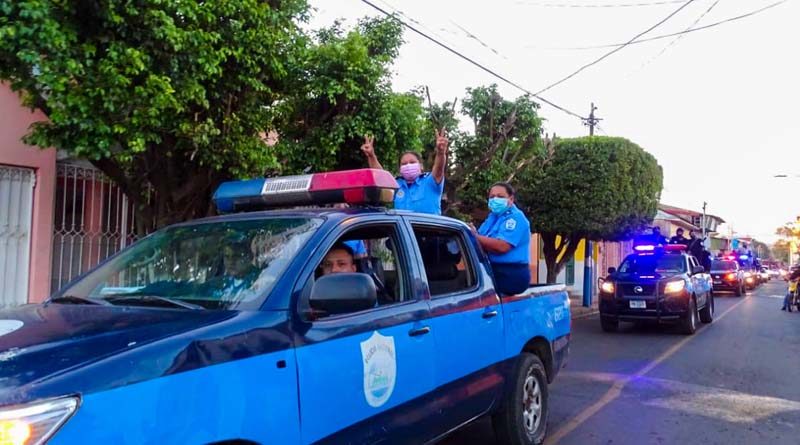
361, 129, 449, 215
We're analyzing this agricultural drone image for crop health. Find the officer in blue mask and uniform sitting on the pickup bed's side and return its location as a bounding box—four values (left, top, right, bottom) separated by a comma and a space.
473, 182, 531, 295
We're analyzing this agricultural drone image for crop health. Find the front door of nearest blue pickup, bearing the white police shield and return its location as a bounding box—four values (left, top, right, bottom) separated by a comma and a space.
296, 219, 437, 444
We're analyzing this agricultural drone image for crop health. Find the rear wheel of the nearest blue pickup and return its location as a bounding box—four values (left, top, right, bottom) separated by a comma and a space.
492, 352, 550, 445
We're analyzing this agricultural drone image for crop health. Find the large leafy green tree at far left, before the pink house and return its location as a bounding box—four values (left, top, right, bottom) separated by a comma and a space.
0, 0, 307, 225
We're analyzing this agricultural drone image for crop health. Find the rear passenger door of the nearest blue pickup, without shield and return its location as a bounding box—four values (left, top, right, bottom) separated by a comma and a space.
410, 219, 504, 426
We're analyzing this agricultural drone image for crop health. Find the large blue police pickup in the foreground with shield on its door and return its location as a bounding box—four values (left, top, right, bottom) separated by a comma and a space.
0, 169, 571, 445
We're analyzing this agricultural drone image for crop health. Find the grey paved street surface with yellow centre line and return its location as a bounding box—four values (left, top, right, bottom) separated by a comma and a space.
445, 280, 800, 445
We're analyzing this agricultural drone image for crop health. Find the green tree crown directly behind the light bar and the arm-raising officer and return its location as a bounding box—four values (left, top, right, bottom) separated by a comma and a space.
277, 19, 423, 174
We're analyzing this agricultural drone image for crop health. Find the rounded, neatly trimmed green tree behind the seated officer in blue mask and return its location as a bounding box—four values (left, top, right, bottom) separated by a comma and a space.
518, 136, 663, 283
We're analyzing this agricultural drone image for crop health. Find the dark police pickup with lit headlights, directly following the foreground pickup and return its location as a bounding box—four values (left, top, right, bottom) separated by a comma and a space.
599, 244, 714, 335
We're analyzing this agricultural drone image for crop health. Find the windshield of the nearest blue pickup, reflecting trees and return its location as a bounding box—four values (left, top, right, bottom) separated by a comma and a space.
54, 218, 321, 310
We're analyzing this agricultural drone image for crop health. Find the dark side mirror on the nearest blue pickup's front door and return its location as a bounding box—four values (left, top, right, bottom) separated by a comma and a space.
308, 273, 378, 315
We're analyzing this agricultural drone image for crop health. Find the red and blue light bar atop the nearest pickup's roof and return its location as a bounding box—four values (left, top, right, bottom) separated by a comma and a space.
213, 168, 397, 213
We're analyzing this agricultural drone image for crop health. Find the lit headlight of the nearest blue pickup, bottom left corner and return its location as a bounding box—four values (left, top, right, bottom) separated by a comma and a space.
0, 397, 78, 445
